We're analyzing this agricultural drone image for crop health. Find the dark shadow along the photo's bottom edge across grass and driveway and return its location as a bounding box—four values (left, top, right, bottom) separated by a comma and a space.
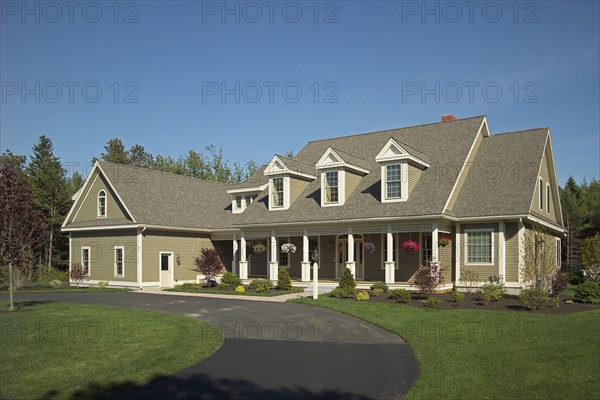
42, 374, 366, 400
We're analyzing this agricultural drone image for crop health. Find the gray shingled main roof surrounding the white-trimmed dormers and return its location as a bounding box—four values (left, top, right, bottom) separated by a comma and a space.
234, 116, 484, 226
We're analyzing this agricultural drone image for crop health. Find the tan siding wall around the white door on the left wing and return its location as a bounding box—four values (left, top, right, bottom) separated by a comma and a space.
142, 230, 212, 284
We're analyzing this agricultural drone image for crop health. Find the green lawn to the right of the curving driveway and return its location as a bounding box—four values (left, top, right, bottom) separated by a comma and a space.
291, 297, 600, 399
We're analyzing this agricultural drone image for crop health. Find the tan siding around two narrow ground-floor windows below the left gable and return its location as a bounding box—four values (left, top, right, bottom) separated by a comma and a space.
71, 230, 137, 282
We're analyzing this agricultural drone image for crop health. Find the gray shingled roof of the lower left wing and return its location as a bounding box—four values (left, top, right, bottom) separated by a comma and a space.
91, 161, 234, 229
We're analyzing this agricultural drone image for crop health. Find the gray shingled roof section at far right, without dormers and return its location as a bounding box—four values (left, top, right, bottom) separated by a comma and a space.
451, 128, 551, 221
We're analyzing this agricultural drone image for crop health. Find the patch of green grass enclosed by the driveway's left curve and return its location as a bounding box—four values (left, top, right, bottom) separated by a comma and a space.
0, 302, 223, 399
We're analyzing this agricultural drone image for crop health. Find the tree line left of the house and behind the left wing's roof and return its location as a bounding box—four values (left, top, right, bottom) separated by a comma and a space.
0, 135, 258, 282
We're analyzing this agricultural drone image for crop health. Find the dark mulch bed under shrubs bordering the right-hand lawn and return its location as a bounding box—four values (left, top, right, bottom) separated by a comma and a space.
360, 293, 600, 314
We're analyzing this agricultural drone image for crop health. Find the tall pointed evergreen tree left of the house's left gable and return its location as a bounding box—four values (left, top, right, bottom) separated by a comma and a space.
27, 135, 71, 270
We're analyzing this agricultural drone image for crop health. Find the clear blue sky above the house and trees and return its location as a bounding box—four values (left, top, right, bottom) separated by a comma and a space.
0, 1, 600, 184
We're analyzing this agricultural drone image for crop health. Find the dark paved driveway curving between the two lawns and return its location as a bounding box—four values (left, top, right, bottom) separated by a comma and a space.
11, 292, 419, 399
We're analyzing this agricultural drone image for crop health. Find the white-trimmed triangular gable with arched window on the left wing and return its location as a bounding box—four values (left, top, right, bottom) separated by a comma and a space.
66, 168, 132, 223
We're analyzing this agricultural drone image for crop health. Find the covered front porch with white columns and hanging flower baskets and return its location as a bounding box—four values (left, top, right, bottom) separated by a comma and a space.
231, 223, 454, 288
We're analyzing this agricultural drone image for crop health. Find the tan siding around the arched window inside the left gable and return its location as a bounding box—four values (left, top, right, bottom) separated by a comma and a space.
73, 172, 127, 221
